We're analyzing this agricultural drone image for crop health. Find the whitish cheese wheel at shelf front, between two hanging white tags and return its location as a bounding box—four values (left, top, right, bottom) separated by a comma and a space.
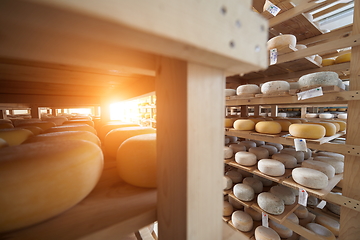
292, 167, 328, 189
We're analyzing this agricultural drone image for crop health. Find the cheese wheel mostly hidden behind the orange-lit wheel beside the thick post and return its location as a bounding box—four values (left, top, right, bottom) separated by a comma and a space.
104, 127, 156, 158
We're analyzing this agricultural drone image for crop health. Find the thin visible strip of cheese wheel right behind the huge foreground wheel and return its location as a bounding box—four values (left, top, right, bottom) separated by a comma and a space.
25, 131, 101, 146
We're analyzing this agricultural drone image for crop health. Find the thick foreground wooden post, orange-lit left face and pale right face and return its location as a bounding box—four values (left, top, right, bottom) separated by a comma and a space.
156, 57, 225, 240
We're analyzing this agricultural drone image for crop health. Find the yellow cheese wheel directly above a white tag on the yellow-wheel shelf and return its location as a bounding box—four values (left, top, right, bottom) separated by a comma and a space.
289, 123, 326, 139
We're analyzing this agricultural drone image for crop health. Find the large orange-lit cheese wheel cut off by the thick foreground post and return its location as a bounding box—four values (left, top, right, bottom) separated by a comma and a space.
116, 133, 157, 188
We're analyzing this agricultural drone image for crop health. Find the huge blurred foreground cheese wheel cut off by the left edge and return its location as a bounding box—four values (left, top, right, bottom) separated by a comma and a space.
0, 140, 103, 232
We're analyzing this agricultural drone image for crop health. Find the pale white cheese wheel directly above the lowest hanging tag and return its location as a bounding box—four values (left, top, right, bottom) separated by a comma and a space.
257, 192, 285, 215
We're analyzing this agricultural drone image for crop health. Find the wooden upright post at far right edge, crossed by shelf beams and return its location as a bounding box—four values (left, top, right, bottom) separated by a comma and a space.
339, 0, 360, 240
